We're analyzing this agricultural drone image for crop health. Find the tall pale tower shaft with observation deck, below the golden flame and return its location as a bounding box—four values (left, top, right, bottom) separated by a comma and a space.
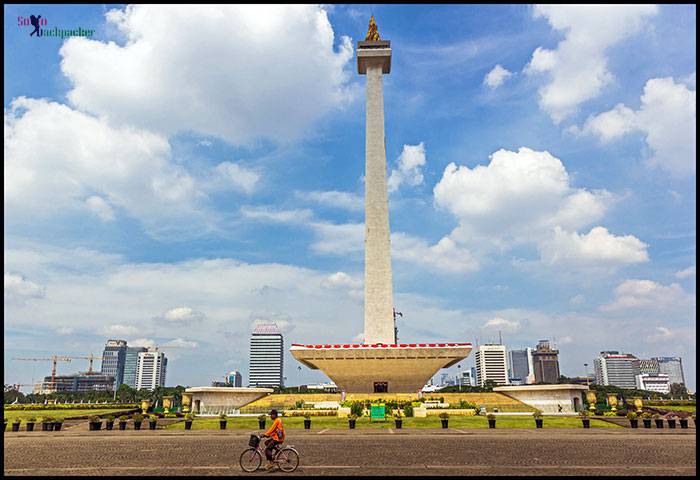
357, 41, 396, 345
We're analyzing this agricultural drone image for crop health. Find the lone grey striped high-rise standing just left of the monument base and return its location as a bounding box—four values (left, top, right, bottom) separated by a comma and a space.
248, 323, 284, 387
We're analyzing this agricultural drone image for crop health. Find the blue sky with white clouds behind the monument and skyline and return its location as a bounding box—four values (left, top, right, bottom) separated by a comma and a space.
4, 5, 696, 389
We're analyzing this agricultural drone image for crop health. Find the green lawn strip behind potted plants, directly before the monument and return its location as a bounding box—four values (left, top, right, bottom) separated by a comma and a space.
166, 416, 623, 431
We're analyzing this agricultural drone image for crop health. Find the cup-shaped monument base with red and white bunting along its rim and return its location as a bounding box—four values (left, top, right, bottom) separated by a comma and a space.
290, 343, 472, 393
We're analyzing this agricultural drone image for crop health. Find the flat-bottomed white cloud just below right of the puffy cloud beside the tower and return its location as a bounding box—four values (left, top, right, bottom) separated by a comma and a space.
540, 227, 649, 266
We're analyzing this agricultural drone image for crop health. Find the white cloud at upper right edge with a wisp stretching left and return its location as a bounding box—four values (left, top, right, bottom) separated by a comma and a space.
572, 77, 696, 176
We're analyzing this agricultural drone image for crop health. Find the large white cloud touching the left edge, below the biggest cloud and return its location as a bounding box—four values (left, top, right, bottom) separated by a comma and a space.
4, 97, 215, 236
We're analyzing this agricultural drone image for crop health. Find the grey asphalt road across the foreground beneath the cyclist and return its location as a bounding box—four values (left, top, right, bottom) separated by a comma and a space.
4, 428, 696, 476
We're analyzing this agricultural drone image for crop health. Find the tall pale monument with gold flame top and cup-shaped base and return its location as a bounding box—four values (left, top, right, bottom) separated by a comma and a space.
290, 17, 472, 395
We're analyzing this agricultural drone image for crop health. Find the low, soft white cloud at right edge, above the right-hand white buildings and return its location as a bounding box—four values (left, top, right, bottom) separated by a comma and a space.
600, 279, 695, 312
